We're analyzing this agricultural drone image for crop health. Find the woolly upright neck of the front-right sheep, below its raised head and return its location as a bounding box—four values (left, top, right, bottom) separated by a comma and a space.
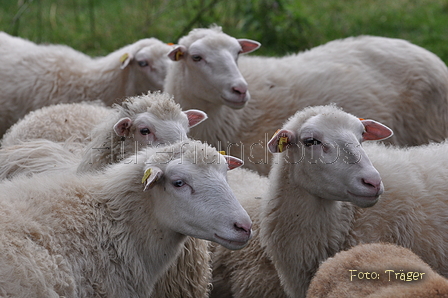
260, 159, 354, 297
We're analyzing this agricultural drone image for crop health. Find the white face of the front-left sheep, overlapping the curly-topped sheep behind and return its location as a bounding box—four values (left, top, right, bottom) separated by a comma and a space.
145, 148, 252, 249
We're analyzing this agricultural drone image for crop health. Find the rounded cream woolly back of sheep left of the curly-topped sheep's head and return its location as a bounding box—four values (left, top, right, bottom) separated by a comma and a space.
1, 101, 111, 147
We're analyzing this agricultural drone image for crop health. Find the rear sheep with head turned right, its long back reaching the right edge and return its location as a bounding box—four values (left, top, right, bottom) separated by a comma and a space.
164, 26, 448, 175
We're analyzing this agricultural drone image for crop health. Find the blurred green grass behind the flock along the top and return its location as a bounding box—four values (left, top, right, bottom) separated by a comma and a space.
0, 0, 448, 63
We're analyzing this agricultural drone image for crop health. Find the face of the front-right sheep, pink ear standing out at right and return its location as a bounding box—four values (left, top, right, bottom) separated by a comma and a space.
270, 106, 392, 207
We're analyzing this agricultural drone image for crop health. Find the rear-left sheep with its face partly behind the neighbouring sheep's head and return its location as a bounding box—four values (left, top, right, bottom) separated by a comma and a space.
0, 32, 172, 136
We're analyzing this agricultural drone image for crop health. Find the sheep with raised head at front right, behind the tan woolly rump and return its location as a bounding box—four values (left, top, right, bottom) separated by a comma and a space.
212, 105, 448, 297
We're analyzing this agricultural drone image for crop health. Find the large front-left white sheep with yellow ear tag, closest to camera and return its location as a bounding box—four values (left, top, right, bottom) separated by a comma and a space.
0, 140, 251, 297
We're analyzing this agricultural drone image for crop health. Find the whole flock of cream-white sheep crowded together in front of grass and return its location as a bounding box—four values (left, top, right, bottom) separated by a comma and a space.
0, 25, 448, 298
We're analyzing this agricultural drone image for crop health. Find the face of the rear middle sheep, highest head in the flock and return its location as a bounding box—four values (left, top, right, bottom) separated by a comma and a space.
168, 33, 260, 109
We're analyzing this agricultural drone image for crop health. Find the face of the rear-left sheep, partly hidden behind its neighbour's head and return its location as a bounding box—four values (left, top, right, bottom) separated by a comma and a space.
121, 38, 172, 96
